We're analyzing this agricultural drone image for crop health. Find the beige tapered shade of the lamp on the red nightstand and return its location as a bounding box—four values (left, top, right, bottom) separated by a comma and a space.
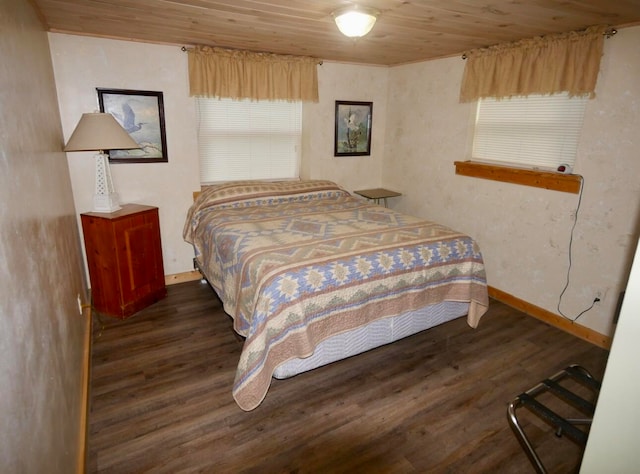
64, 113, 140, 151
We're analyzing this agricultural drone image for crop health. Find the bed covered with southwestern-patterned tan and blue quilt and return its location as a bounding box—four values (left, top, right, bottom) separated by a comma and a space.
183, 180, 488, 411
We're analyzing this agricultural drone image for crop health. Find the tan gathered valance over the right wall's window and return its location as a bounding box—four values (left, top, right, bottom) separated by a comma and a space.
460, 26, 607, 102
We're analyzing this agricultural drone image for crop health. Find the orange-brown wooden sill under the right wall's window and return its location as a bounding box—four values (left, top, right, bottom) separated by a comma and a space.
454, 161, 582, 194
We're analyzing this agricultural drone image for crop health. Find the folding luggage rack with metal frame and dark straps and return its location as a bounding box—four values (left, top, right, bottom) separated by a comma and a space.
507, 364, 600, 474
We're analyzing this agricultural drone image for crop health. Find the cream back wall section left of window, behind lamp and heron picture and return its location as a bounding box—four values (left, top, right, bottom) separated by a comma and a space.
49, 33, 200, 275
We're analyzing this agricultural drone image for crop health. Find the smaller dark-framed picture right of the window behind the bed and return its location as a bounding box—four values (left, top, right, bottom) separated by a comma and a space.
333, 100, 373, 156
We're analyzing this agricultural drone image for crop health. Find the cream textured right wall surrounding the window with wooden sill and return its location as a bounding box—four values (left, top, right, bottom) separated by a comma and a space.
382, 27, 640, 335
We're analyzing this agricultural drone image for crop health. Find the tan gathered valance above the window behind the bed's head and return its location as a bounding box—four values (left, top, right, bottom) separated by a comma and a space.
188, 46, 320, 102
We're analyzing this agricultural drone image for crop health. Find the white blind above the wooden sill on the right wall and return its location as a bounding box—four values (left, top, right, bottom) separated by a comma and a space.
472, 93, 588, 169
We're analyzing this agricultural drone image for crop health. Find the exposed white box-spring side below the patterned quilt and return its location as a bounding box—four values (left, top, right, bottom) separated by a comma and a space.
273, 301, 469, 379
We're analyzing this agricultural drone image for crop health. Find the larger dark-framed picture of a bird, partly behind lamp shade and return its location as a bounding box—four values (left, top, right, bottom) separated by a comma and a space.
96, 88, 169, 163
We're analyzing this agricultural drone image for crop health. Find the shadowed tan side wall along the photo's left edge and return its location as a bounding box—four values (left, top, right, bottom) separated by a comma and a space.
0, 0, 89, 473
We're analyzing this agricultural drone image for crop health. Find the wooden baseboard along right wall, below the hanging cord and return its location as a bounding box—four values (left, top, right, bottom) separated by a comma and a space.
489, 286, 612, 349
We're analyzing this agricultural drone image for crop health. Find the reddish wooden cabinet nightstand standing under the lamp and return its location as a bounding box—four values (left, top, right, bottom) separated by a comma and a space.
80, 204, 167, 318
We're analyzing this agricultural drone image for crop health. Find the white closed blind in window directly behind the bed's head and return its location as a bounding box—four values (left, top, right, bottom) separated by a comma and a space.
196, 98, 302, 184
